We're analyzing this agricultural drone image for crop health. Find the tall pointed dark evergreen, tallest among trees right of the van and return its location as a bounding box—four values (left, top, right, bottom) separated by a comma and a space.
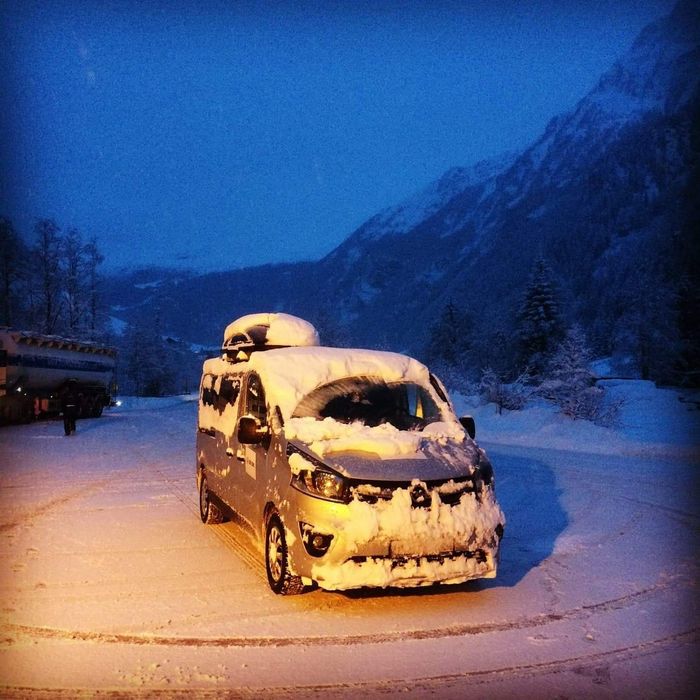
517, 258, 562, 375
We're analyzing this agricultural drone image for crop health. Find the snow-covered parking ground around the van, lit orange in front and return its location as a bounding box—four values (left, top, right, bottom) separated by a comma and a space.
0, 382, 700, 698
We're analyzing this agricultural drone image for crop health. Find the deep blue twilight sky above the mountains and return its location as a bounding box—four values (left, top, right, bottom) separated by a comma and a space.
0, 0, 673, 270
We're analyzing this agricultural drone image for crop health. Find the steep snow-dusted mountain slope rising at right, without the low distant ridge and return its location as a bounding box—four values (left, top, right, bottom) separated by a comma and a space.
310, 2, 700, 351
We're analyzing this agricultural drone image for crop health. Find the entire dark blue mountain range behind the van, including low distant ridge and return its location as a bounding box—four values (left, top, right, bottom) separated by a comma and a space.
104, 1, 700, 382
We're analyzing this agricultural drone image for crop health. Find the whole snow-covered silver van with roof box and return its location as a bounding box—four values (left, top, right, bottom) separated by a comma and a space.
196, 313, 505, 594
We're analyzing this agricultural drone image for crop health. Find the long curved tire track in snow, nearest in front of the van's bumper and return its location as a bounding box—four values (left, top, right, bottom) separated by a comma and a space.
2, 578, 688, 647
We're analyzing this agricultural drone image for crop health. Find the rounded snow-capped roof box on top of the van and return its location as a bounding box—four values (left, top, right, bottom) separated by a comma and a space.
222, 313, 319, 355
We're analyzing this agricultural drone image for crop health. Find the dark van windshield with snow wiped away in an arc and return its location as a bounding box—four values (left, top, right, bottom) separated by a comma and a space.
293, 377, 443, 430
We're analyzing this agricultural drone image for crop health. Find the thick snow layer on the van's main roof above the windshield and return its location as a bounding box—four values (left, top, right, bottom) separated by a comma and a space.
200, 347, 430, 419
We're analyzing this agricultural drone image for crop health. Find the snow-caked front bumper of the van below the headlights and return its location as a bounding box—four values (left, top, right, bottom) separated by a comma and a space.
287, 497, 505, 590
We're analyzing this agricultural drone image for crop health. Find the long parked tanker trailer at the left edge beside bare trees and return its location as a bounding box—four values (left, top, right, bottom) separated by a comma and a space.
0, 328, 117, 423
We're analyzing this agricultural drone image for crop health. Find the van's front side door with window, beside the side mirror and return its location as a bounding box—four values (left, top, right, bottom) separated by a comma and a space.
236, 372, 270, 524
